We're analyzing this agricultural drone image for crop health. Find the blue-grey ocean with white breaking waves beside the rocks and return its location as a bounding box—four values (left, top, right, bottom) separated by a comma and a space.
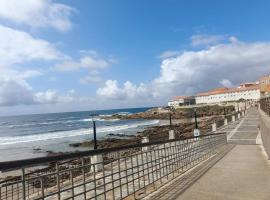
0, 108, 159, 162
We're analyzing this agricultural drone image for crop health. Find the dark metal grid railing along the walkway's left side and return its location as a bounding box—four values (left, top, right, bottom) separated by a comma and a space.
0, 133, 227, 200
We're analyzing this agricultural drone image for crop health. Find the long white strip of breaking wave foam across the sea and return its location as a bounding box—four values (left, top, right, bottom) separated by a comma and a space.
0, 120, 159, 146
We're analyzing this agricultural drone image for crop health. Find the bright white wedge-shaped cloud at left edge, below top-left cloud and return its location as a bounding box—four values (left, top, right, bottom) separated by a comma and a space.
0, 25, 62, 67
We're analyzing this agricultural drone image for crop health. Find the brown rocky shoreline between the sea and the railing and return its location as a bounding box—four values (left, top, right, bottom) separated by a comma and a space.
44, 105, 234, 156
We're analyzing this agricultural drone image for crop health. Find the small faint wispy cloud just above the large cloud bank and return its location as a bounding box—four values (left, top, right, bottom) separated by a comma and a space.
191, 34, 225, 47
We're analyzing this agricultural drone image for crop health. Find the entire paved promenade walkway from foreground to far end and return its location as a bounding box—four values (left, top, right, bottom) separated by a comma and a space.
150, 108, 270, 200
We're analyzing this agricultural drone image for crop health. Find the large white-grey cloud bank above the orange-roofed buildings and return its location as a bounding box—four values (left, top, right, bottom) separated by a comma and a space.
97, 37, 270, 103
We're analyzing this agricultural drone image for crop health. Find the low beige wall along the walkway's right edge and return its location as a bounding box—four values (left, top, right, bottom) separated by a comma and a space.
259, 109, 270, 159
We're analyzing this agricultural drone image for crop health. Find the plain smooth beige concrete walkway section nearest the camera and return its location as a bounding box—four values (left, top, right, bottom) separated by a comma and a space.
177, 145, 270, 200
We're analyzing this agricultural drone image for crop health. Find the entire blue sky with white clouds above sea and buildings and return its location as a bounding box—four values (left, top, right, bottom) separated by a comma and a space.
0, 0, 270, 115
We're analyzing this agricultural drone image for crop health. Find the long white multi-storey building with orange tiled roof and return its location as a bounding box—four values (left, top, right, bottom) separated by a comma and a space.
196, 83, 261, 104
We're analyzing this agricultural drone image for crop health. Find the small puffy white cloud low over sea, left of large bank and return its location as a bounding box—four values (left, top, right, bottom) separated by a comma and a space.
97, 80, 148, 100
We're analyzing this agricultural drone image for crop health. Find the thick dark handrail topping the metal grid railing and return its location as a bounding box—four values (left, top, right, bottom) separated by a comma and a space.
0, 133, 226, 172
